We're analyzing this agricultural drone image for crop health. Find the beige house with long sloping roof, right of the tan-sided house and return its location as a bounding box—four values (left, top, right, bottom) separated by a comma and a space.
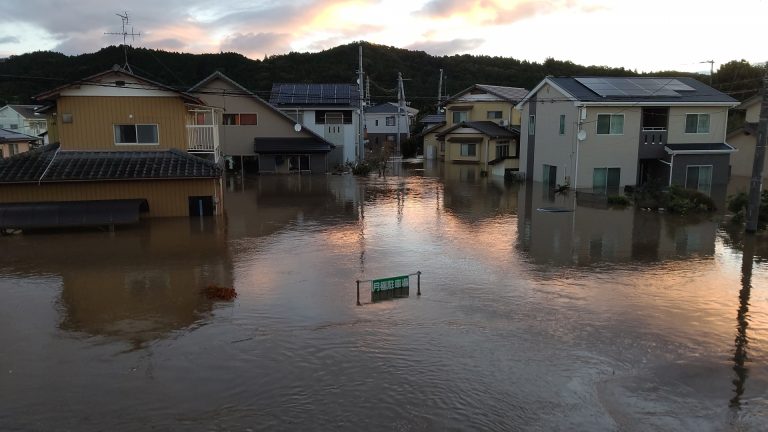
188, 71, 334, 174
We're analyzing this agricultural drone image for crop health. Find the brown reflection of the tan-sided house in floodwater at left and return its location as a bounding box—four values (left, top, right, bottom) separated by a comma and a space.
4, 219, 233, 348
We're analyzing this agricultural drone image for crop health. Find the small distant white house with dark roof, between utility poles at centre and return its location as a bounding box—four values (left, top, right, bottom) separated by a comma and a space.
365, 102, 419, 152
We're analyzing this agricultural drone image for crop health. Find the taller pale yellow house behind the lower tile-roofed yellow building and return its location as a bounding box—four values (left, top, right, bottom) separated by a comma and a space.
422, 84, 528, 160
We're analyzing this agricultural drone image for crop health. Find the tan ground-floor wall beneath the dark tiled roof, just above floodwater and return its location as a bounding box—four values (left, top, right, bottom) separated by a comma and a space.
0, 179, 222, 217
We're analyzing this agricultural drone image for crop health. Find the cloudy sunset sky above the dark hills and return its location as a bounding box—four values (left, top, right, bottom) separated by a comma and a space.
0, 0, 768, 71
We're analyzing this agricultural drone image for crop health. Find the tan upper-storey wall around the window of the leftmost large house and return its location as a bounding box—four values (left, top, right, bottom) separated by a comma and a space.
50, 96, 187, 151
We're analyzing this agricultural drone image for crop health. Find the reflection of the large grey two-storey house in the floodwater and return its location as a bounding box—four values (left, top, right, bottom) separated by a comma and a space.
518, 183, 718, 266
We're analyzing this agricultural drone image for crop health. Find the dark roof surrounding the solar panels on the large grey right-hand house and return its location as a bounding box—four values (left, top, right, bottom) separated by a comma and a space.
547, 77, 737, 103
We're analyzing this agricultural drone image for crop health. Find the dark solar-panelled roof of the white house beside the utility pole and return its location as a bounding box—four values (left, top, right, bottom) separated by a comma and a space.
269, 83, 360, 107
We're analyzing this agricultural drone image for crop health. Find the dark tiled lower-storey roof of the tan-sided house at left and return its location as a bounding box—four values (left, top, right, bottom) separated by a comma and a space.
0, 144, 221, 183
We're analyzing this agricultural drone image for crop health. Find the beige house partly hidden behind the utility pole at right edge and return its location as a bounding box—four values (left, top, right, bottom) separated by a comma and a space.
727, 94, 768, 184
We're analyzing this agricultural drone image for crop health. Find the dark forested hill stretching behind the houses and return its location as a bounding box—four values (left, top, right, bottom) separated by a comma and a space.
0, 43, 761, 109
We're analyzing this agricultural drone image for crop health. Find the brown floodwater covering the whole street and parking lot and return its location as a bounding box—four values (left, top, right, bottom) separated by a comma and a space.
0, 165, 768, 431
